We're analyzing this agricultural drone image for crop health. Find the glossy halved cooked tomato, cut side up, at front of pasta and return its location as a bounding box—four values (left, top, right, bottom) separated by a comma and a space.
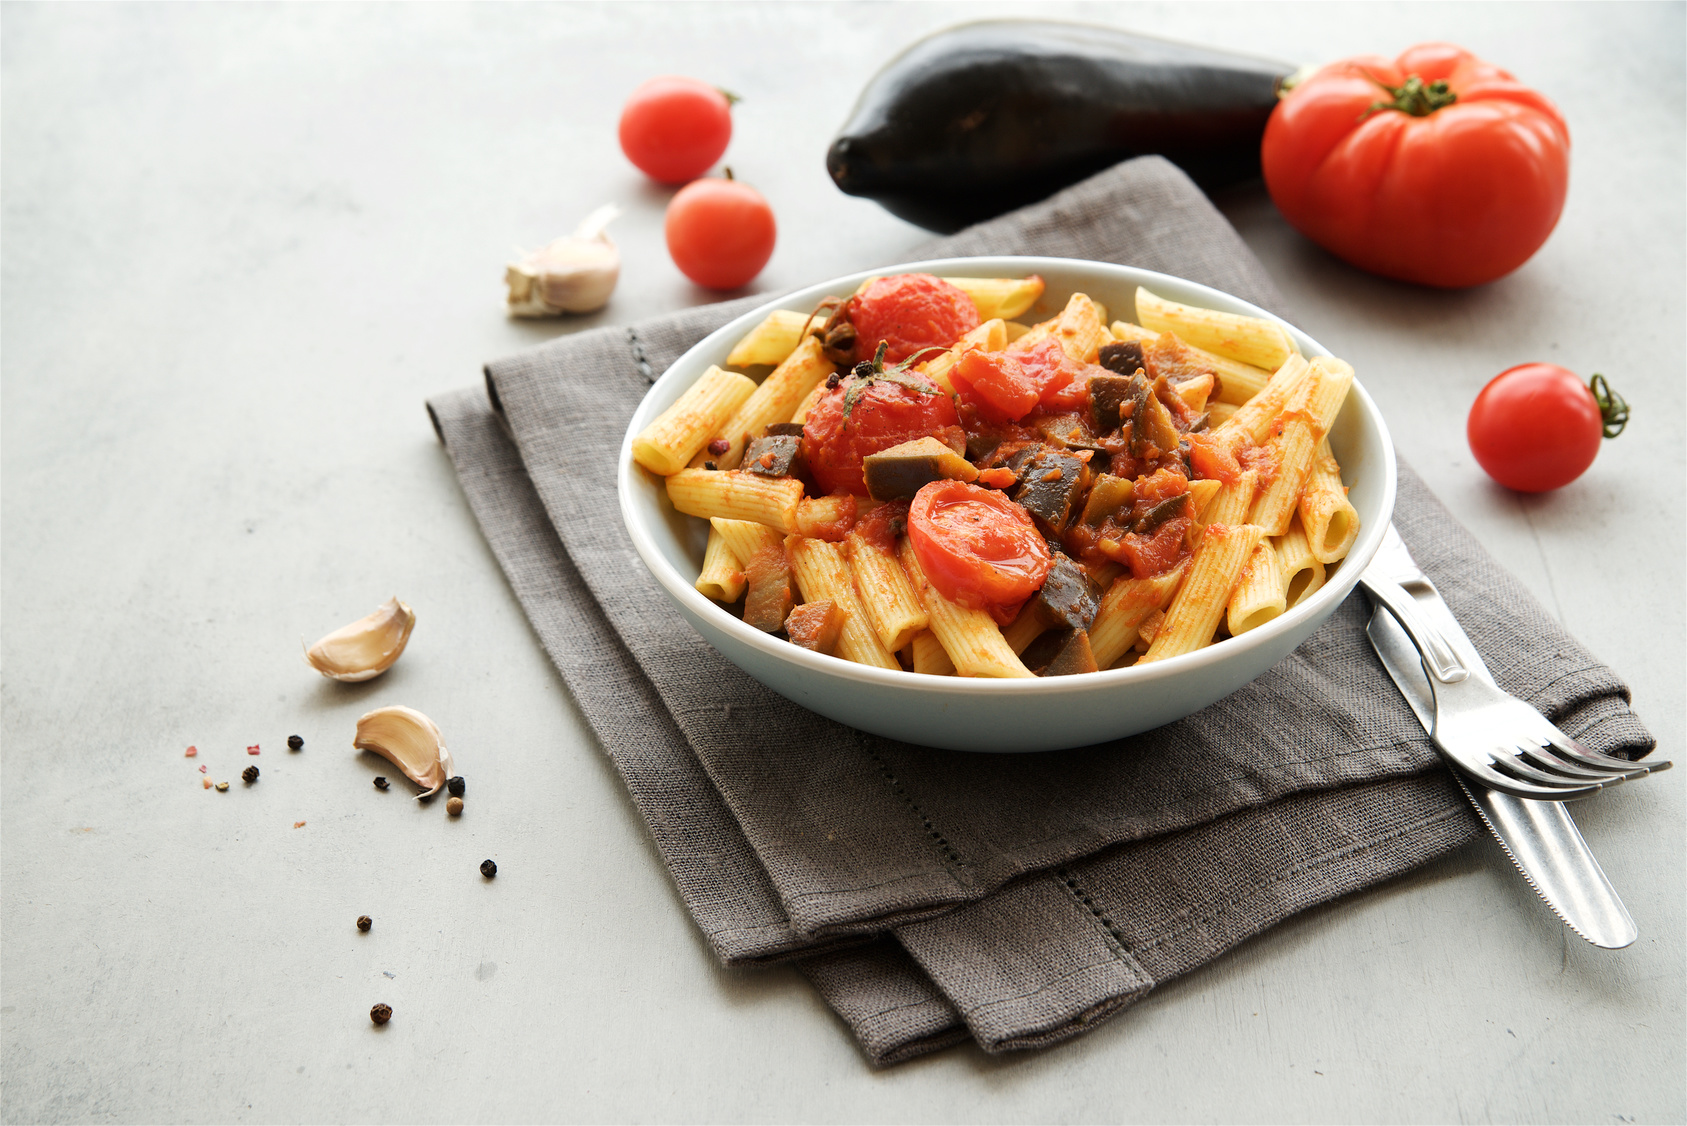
908, 481, 1054, 609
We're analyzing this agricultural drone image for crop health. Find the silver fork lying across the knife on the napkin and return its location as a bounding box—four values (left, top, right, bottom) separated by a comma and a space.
1360, 527, 1670, 802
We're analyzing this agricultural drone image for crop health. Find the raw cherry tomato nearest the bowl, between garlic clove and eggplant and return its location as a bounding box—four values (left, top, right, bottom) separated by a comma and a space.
666, 169, 778, 289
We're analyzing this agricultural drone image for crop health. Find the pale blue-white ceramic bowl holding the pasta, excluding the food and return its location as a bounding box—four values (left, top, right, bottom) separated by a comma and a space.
617, 257, 1395, 751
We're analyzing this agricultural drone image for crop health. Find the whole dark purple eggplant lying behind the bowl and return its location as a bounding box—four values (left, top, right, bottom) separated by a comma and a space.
827, 20, 1294, 231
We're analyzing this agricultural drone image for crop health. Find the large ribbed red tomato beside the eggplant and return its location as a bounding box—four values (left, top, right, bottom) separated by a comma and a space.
1260, 44, 1571, 289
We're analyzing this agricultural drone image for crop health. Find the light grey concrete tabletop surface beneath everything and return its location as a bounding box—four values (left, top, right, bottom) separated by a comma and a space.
0, 3, 1687, 1123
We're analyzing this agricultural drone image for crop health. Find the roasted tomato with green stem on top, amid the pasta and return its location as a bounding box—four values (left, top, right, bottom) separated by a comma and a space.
803, 373, 960, 496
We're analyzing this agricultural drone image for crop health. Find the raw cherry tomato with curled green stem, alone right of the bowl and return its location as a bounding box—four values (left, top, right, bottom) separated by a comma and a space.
1464, 363, 1628, 493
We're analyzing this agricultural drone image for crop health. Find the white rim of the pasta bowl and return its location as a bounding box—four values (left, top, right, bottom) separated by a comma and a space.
616, 255, 1397, 699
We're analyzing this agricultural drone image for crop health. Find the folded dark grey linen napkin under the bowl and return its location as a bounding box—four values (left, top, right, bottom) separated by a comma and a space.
428, 159, 1652, 1062
